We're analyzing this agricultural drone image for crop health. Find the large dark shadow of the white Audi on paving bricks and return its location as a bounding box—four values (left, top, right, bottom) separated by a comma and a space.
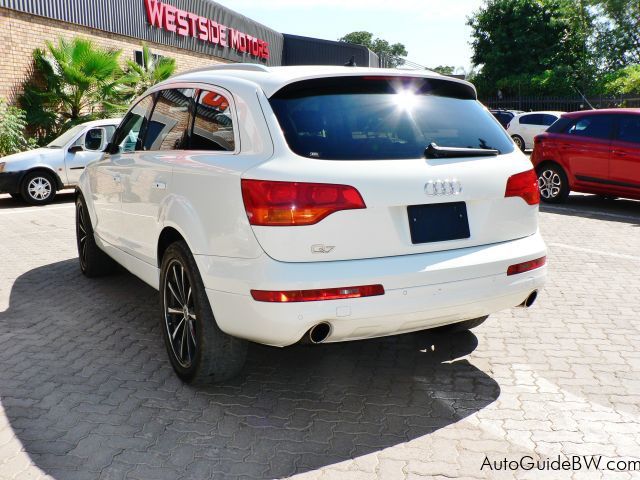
0, 259, 500, 480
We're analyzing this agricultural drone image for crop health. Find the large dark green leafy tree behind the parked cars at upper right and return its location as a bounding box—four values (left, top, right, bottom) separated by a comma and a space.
468, 0, 596, 95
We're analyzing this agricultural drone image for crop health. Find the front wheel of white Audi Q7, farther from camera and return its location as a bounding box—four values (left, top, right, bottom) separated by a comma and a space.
76, 195, 118, 278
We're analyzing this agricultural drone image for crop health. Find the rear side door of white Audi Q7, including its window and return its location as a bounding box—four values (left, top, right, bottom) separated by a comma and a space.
121, 89, 194, 264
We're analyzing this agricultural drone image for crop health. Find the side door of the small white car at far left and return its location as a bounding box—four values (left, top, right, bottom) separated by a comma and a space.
64, 125, 116, 185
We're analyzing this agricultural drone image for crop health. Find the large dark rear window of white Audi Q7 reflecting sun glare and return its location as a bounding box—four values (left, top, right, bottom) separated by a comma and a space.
270, 77, 513, 160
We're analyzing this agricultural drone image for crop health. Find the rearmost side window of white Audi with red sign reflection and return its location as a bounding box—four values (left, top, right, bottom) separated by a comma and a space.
191, 90, 236, 152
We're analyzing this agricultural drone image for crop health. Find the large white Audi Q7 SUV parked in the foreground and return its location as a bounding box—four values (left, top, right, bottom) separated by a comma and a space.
76, 64, 546, 382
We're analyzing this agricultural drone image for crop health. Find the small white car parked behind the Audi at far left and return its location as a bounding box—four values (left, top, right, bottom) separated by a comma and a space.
0, 118, 121, 205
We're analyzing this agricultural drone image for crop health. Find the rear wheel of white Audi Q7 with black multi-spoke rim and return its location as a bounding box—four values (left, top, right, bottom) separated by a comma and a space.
160, 241, 248, 384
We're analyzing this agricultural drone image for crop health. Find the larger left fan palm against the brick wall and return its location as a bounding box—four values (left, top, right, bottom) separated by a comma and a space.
20, 38, 126, 142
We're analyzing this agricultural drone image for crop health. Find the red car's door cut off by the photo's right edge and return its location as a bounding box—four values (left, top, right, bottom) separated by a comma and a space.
609, 114, 640, 189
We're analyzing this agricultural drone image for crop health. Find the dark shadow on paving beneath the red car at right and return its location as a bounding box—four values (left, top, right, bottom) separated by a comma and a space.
540, 194, 640, 227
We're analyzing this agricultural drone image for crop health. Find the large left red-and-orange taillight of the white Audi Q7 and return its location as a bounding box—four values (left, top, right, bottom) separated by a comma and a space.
242, 180, 367, 227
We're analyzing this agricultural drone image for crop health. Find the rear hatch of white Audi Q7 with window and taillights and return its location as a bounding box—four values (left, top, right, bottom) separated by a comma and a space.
242, 75, 537, 262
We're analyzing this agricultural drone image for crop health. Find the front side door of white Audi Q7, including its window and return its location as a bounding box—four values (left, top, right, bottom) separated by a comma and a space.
91, 96, 153, 248
